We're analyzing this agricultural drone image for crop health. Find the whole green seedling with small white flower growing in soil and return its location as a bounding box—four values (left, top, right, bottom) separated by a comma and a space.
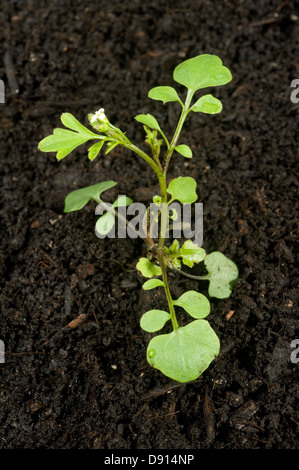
39, 54, 238, 382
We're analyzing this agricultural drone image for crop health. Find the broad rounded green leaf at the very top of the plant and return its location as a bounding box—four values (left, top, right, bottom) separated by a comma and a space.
173, 54, 232, 93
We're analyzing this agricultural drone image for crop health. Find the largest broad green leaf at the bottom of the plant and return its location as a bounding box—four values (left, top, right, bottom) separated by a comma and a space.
147, 320, 220, 383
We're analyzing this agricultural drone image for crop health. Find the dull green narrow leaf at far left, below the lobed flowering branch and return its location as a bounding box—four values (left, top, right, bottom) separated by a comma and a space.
64, 181, 117, 212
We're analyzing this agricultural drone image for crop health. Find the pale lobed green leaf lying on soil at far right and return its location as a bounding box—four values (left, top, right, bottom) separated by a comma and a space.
202, 251, 239, 299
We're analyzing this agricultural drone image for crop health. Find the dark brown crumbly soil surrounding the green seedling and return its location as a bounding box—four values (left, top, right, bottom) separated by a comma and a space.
0, 0, 299, 449
